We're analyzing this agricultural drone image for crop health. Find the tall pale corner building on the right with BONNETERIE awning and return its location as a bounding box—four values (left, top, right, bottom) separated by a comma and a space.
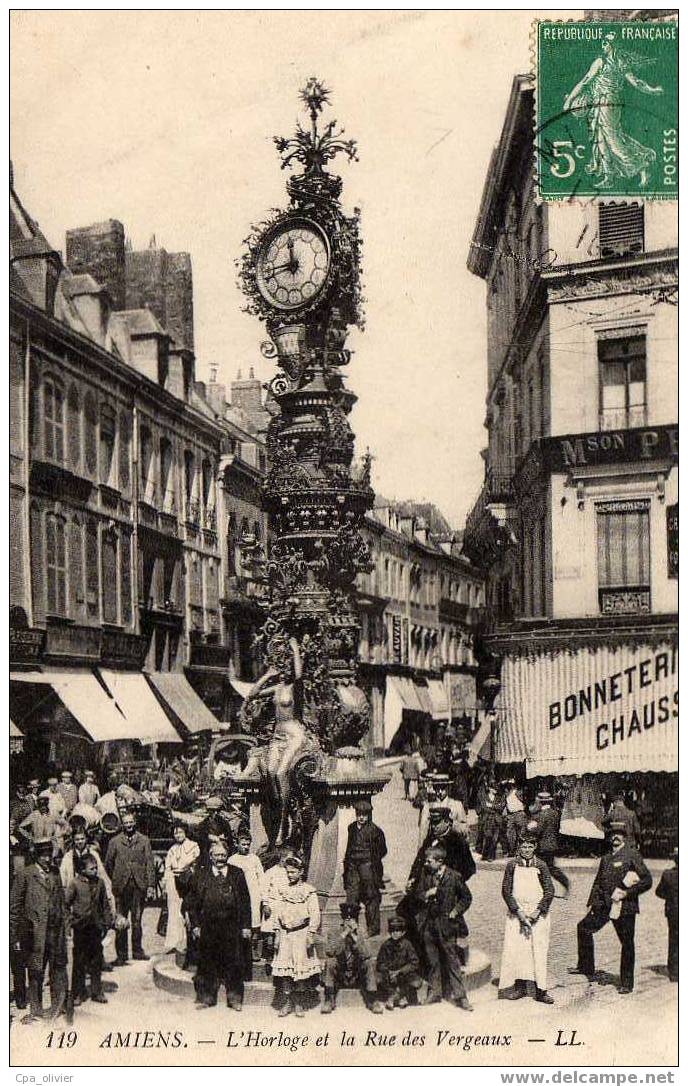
464, 76, 678, 855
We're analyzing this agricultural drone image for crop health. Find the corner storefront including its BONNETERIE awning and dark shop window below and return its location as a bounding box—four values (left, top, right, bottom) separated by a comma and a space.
493, 635, 678, 855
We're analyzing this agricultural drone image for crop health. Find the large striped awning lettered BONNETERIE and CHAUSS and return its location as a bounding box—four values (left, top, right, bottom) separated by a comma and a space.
494, 644, 678, 776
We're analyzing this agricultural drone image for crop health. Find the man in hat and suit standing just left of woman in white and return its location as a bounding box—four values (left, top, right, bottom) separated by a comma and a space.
105, 811, 155, 965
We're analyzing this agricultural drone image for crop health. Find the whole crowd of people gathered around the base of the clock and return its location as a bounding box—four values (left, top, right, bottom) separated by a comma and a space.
10, 761, 678, 1022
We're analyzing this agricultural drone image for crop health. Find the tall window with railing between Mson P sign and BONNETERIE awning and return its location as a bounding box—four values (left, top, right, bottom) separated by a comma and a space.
596, 501, 650, 615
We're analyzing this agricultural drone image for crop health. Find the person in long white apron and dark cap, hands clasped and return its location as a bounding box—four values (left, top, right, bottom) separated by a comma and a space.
499, 829, 555, 1003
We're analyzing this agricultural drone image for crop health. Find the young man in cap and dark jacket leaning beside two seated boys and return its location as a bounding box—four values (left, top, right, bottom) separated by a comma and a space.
415, 846, 473, 1011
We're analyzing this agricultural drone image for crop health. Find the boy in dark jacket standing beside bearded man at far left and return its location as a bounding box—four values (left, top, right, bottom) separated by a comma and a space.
65, 854, 115, 1007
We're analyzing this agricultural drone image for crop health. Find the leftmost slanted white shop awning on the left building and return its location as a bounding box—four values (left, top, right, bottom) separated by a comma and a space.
10, 668, 134, 743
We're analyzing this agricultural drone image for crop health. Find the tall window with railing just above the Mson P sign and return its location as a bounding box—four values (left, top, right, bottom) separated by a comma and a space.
597, 334, 647, 430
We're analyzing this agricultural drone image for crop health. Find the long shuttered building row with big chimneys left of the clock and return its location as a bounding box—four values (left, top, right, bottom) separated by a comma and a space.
10, 175, 266, 765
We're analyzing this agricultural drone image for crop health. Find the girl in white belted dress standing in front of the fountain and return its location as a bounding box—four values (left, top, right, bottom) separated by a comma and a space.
272, 856, 322, 1018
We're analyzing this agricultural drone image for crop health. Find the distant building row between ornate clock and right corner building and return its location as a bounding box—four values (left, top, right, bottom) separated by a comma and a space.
358, 497, 483, 752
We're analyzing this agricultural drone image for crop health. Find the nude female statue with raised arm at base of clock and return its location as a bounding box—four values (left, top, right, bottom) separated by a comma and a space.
242, 637, 319, 845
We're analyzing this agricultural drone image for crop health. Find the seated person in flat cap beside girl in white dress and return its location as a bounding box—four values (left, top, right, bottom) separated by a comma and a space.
320, 904, 383, 1014
